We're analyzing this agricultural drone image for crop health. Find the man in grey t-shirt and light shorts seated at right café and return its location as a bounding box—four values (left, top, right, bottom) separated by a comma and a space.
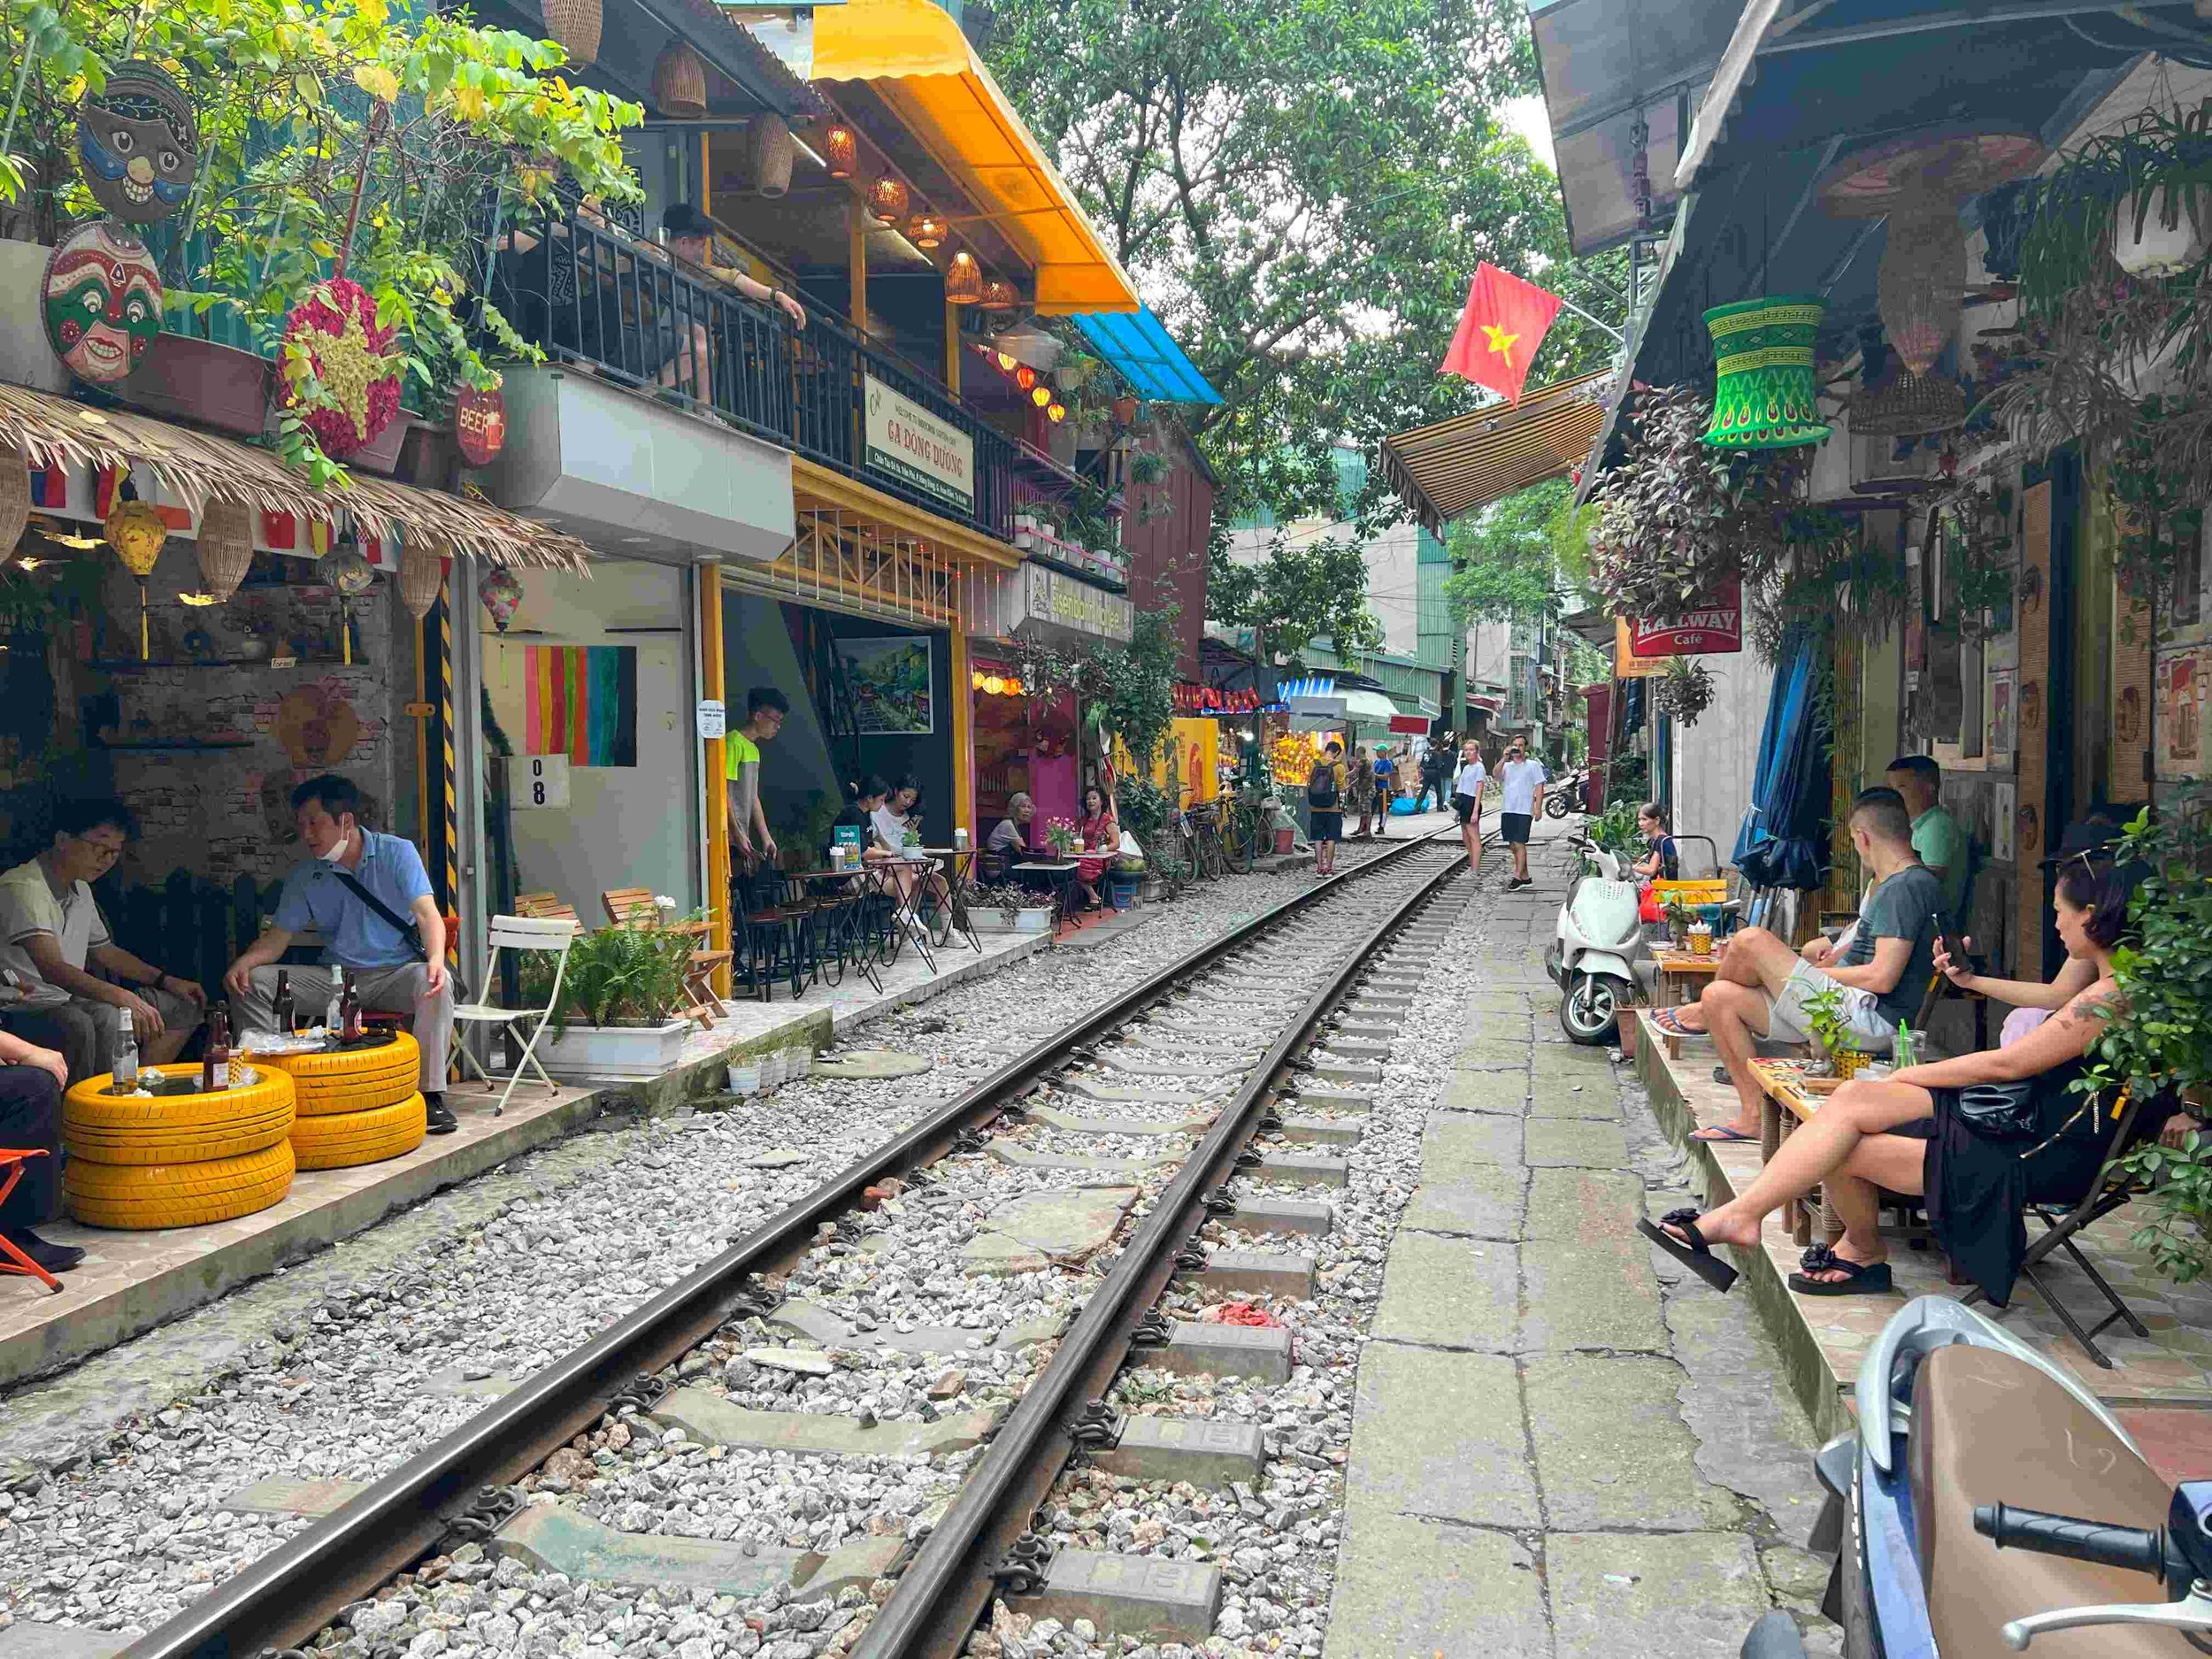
1681, 790, 1942, 1141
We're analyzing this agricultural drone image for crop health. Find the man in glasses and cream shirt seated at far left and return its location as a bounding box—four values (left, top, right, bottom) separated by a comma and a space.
0, 801, 208, 1078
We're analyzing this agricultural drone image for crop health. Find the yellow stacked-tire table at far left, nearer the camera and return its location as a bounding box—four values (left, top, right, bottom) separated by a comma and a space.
62, 1066, 295, 1228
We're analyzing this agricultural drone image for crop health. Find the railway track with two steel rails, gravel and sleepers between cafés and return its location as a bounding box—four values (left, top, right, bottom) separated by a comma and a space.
127, 839, 1464, 1659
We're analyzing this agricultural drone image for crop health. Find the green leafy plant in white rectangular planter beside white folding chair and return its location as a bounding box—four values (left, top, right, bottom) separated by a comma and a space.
522, 918, 697, 1079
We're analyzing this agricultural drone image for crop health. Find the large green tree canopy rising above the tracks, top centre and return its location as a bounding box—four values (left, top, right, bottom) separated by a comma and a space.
989, 0, 1622, 534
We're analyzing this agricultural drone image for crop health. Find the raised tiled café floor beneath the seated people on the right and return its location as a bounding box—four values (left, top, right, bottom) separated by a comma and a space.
1637, 1026, 2212, 1407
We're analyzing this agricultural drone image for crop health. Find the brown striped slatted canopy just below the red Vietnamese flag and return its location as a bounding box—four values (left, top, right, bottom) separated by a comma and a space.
1383, 370, 1609, 535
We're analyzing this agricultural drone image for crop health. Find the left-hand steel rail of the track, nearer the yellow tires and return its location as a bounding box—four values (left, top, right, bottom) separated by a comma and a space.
122, 834, 1442, 1659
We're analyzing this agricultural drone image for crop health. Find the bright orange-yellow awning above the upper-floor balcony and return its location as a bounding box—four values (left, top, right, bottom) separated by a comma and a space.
814, 0, 1137, 317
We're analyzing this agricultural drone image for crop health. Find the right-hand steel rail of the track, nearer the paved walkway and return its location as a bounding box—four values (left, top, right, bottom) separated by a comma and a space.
852, 852, 1467, 1659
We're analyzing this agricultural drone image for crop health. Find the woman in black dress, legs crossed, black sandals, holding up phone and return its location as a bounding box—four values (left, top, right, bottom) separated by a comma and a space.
1637, 863, 2172, 1305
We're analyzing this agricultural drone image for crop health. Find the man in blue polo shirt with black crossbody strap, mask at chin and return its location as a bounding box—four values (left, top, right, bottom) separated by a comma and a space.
224, 774, 458, 1135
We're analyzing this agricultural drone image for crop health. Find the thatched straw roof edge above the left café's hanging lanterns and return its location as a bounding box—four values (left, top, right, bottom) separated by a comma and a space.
0, 380, 591, 575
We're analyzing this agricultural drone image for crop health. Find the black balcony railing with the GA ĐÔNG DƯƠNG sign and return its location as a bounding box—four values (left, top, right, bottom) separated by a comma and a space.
491, 215, 1013, 542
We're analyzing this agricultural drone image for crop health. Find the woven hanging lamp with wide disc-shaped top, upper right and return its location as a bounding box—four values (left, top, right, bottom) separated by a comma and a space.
1816, 124, 2051, 374
